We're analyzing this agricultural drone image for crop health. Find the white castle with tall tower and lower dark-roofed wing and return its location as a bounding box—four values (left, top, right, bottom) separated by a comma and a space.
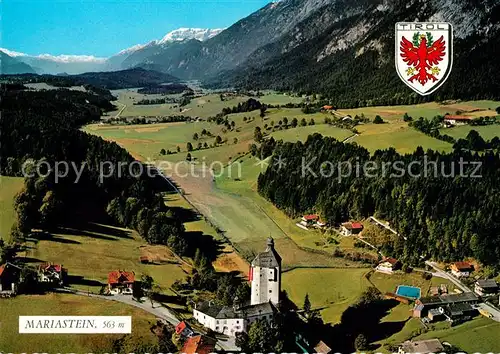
193, 238, 281, 336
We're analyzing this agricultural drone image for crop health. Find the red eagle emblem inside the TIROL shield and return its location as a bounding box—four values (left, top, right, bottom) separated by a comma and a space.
400, 33, 446, 85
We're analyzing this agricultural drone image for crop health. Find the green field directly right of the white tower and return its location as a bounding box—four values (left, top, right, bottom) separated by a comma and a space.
282, 268, 370, 324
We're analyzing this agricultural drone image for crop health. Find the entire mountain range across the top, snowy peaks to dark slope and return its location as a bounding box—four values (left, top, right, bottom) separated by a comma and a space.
2, 0, 500, 106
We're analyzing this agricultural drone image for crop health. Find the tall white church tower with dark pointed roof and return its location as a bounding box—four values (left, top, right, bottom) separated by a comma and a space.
249, 237, 281, 305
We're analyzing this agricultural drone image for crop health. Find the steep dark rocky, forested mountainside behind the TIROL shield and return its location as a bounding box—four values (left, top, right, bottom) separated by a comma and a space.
211, 0, 500, 107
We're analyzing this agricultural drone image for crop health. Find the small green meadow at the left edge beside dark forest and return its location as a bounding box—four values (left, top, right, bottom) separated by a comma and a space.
0, 176, 24, 241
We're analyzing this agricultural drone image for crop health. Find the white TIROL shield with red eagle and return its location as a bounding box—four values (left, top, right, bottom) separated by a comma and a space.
395, 22, 453, 96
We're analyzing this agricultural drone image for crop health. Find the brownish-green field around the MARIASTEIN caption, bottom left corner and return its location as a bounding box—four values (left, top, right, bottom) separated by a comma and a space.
0, 294, 156, 353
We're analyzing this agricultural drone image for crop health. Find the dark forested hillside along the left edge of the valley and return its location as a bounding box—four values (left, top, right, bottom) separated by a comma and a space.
0, 85, 194, 254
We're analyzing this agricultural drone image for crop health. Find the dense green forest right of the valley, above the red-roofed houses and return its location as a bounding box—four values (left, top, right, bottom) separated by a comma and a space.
258, 134, 500, 268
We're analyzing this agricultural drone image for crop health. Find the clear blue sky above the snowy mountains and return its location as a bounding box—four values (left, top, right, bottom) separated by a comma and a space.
0, 0, 270, 57
